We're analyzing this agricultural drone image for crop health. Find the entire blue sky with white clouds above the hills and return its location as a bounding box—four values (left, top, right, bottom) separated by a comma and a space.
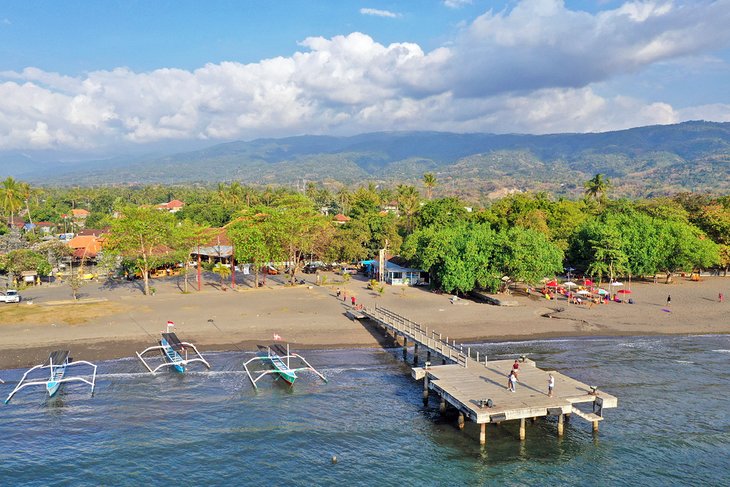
0, 0, 730, 152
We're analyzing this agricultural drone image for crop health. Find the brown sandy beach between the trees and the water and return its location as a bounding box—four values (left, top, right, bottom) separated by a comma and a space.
0, 274, 730, 369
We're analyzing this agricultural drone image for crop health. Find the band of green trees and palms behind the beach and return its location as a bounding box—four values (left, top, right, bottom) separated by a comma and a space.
0, 174, 730, 293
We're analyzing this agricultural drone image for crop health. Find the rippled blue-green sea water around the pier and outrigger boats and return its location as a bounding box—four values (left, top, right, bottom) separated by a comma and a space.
0, 336, 730, 487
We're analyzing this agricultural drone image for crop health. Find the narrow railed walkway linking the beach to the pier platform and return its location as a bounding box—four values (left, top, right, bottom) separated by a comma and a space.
363, 305, 480, 367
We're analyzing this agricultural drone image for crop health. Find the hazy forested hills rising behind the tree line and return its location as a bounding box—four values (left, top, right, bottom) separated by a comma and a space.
12, 122, 730, 197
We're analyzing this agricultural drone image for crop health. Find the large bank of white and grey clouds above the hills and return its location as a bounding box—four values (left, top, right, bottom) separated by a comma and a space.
0, 0, 730, 150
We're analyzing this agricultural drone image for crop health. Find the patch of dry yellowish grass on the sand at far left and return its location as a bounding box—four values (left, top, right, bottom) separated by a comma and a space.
0, 302, 124, 326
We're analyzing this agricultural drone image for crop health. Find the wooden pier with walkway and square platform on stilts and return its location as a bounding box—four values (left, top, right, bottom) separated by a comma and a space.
362, 306, 618, 445
